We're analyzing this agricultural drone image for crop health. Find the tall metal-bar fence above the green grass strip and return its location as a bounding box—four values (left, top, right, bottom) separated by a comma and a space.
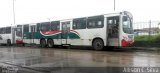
133, 21, 160, 36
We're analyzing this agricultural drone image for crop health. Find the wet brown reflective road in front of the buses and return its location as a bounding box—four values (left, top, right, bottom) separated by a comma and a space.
0, 47, 160, 73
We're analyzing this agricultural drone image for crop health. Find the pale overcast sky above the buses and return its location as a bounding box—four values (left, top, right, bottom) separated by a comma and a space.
0, 0, 160, 27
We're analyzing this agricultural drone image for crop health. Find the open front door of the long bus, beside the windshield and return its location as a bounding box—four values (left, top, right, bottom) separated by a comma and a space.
107, 16, 120, 46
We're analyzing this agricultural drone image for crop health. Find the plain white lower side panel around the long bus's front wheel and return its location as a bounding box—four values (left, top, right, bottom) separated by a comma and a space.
69, 26, 106, 46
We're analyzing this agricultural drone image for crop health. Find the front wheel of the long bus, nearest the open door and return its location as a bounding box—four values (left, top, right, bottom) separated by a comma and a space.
92, 39, 104, 50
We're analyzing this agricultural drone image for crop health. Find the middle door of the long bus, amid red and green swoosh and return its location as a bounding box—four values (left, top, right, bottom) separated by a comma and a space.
61, 21, 70, 44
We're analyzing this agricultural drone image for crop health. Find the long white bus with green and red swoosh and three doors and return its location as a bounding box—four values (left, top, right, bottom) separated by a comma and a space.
23, 11, 134, 50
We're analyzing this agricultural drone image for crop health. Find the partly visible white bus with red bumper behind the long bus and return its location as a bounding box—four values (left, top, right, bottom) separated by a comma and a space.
0, 25, 23, 46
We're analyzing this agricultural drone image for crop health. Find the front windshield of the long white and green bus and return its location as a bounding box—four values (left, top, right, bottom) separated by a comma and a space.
122, 16, 133, 34
